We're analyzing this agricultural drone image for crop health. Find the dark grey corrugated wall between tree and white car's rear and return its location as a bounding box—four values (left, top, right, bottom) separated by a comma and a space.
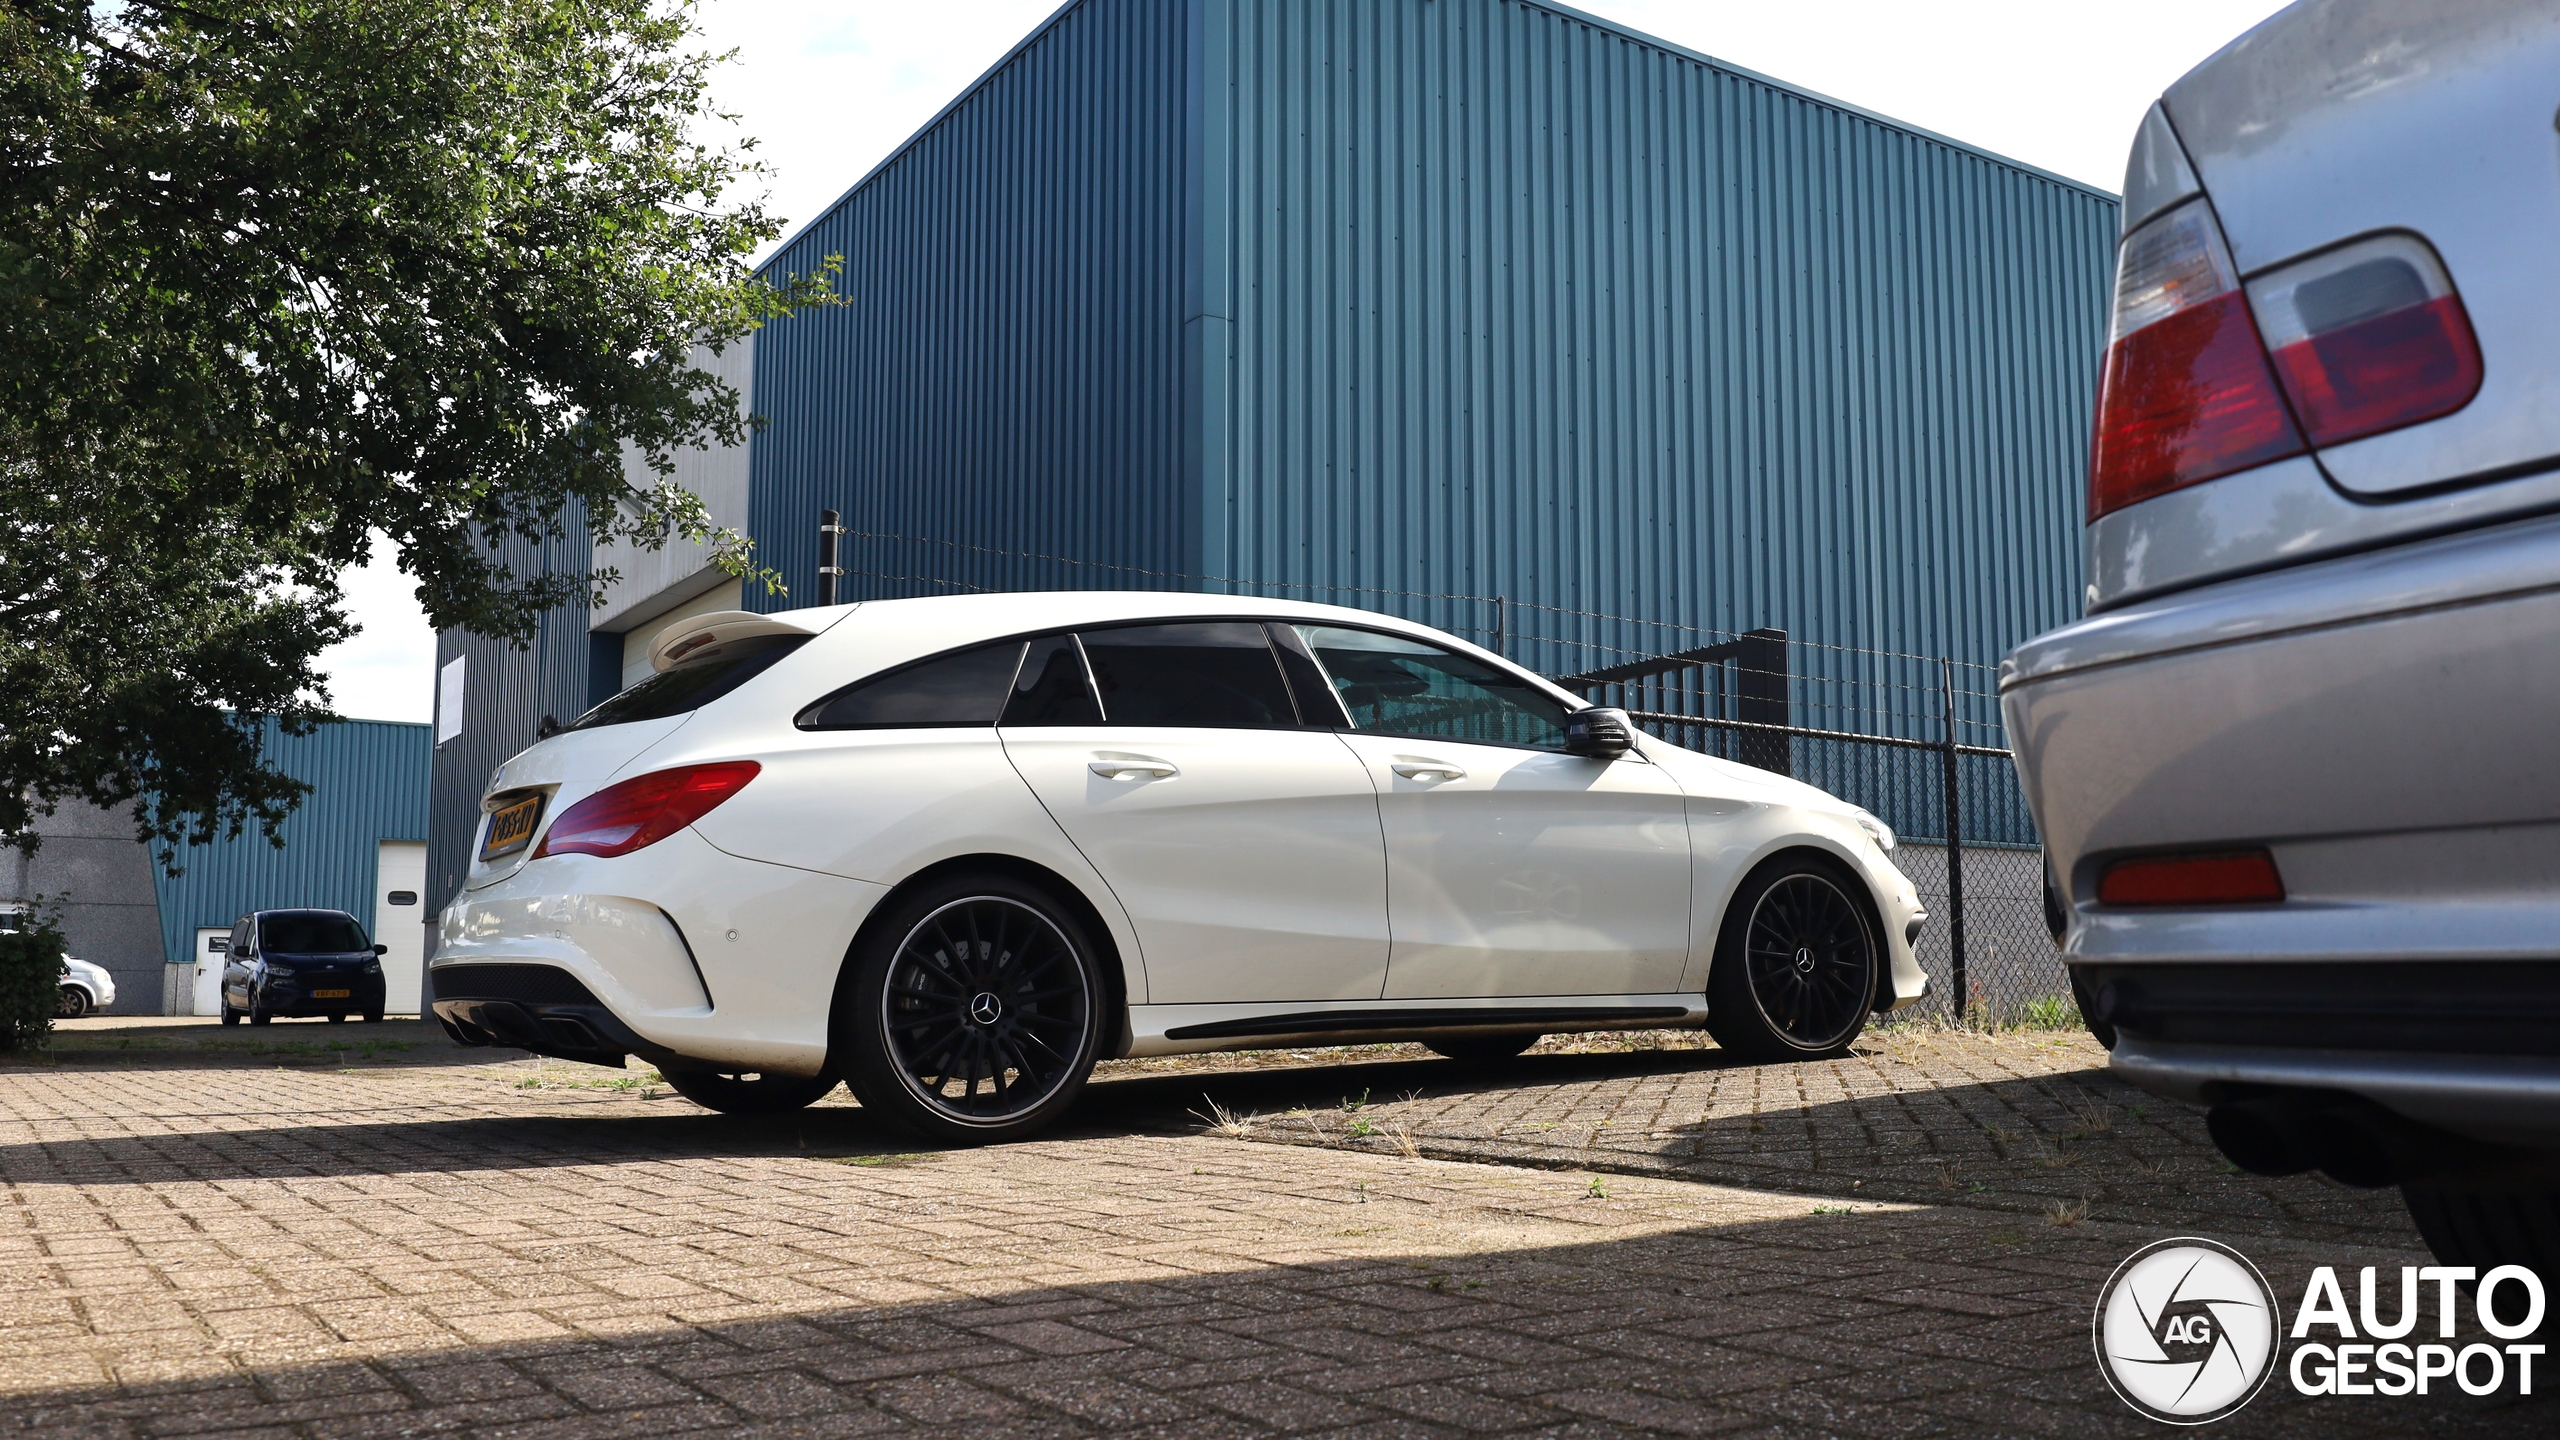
428, 525, 599, 917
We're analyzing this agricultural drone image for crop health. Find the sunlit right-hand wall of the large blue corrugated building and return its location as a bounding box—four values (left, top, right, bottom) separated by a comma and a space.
1208, 0, 2117, 738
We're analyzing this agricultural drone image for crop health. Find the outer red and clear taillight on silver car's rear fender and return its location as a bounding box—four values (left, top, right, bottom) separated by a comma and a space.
2089, 200, 2304, 520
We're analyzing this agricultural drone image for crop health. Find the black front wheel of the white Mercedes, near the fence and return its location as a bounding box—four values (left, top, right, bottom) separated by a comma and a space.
1708, 853, 1884, 1061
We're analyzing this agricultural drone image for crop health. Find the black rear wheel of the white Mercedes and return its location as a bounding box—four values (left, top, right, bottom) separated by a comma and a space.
835, 876, 1108, 1143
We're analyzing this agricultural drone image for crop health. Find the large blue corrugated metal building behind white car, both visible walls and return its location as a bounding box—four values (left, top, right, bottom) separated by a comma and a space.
750, 0, 2117, 840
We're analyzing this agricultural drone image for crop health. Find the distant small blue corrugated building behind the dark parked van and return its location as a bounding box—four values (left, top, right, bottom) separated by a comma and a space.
148, 720, 435, 963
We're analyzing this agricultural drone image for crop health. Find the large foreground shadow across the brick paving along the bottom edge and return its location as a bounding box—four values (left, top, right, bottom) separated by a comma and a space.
0, 1194, 2519, 1440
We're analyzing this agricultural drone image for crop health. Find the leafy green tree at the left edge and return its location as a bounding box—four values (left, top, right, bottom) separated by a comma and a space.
0, 0, 827, 848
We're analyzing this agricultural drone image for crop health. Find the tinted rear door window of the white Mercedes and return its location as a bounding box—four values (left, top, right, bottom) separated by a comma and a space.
1083, 620, 1298, 728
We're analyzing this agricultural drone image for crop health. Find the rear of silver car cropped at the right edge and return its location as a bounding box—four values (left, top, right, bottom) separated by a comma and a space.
2002, 0, 2560, 1296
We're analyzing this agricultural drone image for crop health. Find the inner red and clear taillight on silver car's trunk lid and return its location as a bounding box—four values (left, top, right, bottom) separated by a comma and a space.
2248, 233, 2481, 446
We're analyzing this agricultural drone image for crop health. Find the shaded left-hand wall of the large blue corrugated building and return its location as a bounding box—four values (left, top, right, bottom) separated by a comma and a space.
750, 0, 1198, 610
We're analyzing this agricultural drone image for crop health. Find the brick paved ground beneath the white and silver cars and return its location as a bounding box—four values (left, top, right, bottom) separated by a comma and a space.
0, 1025, 2560, 1437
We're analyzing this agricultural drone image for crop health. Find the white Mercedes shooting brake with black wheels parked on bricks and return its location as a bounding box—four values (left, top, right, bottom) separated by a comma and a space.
430, 592, 1925, 1140
